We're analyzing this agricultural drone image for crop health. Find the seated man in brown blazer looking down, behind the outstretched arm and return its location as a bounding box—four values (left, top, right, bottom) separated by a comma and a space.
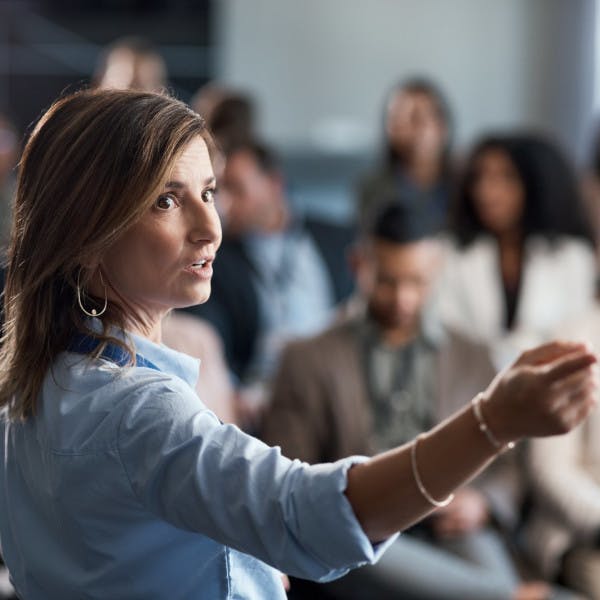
262, 205, 548, 600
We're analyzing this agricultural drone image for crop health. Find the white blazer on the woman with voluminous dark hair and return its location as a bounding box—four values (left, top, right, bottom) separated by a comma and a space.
435, 236, 596, 368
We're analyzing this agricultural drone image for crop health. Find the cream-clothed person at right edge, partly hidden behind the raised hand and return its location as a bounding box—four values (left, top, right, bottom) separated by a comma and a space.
524, 304, 600, 599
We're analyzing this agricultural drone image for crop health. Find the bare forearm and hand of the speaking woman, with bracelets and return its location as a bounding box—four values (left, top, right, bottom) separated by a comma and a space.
346, 342, 596, 541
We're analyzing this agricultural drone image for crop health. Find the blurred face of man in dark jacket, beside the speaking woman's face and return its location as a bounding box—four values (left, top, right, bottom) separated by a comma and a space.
219, 150, 282, 235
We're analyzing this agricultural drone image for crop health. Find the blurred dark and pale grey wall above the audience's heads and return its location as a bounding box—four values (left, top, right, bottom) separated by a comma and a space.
0, 0, 600, 220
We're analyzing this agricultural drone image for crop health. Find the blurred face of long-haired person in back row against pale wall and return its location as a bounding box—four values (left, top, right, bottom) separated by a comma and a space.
386, 92, 448, 158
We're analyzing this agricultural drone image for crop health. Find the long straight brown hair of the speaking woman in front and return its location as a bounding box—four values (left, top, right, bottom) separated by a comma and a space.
0, 90, 211, 419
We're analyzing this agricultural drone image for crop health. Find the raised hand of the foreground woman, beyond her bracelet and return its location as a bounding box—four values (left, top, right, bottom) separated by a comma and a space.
481, 342, 597, 443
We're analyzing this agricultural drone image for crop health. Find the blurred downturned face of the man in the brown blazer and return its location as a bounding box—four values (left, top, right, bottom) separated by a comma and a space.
356, 240, 440, 330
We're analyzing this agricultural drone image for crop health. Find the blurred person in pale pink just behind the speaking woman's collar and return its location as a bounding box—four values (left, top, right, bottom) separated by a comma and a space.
162, 312, 237, 423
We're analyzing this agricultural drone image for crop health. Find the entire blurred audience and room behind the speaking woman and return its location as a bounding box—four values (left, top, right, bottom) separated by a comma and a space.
0, 0, 600, 600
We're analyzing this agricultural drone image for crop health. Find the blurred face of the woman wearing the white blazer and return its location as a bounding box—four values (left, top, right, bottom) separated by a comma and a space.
472, 150, 525, 234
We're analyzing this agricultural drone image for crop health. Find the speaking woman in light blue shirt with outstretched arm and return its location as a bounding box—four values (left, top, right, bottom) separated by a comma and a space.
0, 91, 596, 599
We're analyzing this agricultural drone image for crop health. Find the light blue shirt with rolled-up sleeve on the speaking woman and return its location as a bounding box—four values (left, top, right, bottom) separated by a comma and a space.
0, 336, 393, 600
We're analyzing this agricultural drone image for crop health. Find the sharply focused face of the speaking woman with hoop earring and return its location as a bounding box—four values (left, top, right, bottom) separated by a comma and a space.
96, 136, 221, 325
